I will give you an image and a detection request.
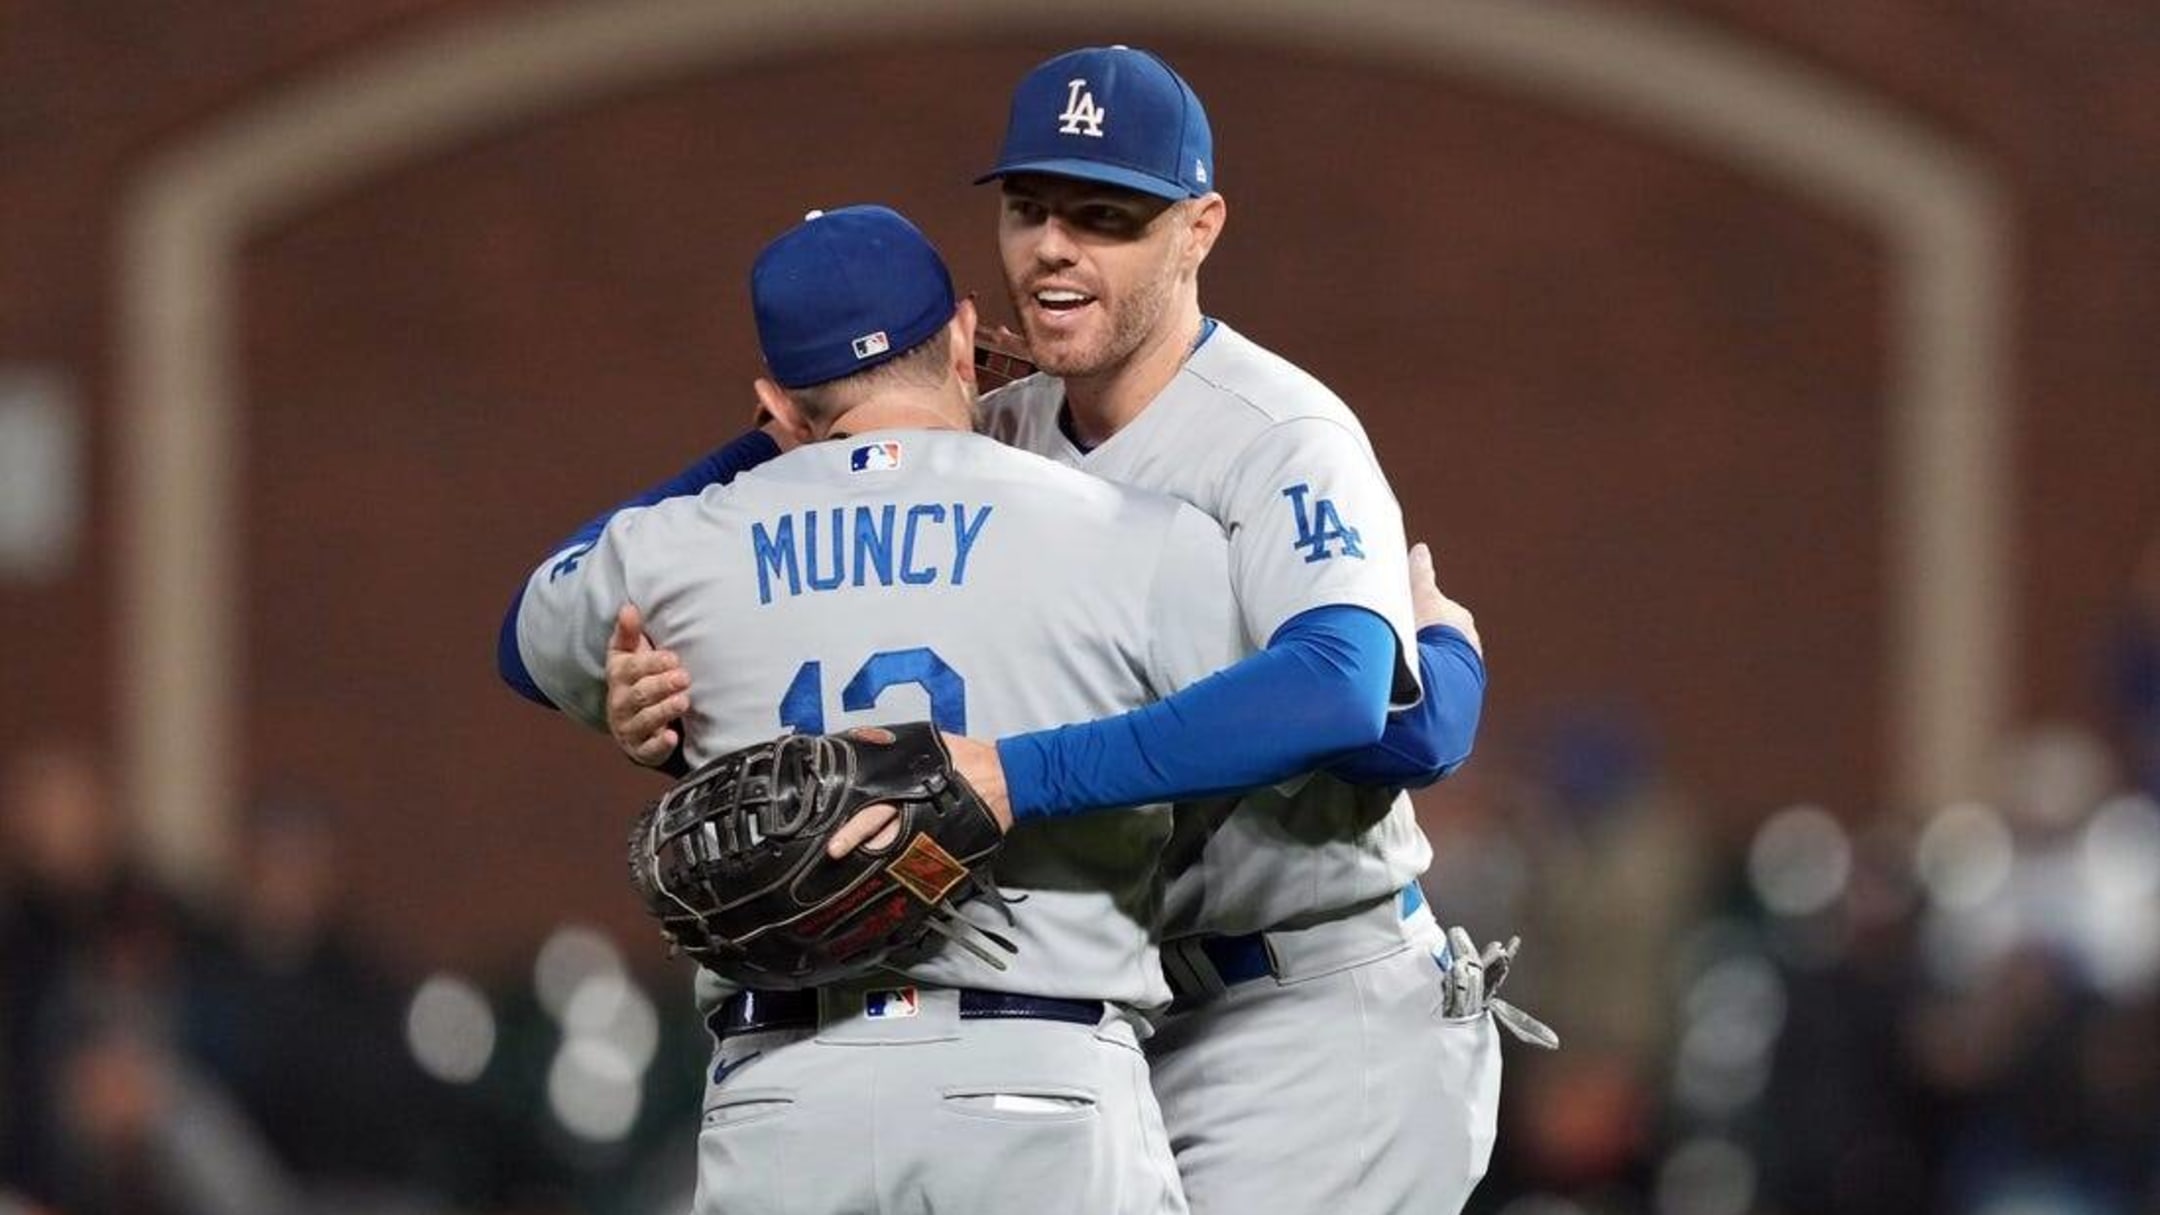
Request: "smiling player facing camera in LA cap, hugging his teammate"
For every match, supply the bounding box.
[591,48,1499,1215]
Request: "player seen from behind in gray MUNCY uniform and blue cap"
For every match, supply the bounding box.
[505,208,1442,1213]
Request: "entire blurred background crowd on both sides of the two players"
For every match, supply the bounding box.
[0,547,2160,1215]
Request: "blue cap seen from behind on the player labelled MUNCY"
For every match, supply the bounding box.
[750,205,957,389]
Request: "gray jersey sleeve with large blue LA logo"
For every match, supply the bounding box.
[1223,417,1419,707]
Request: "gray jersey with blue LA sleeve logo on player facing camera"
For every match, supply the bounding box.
[981,324,1432,938]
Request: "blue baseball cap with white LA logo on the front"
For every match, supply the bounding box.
[974,45,1214,201]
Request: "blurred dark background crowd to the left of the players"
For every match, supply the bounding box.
[0,744,702,1215]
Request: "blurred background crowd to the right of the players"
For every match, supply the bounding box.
[1428,709,2160,1215]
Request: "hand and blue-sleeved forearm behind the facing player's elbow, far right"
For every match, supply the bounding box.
[1328,545,1486,789]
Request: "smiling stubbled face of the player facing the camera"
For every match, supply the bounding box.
[998,173,1186,378]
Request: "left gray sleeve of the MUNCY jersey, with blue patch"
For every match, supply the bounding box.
[518,506,650,731]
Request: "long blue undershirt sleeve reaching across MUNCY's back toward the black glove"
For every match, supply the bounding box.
[998,605,1395,819]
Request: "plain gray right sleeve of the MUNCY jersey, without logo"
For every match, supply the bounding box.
[1147,504,1257,696]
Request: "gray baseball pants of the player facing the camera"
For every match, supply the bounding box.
[1147,902,1501,1215]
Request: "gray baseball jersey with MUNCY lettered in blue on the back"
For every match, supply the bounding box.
[518,430,1244,1007]
